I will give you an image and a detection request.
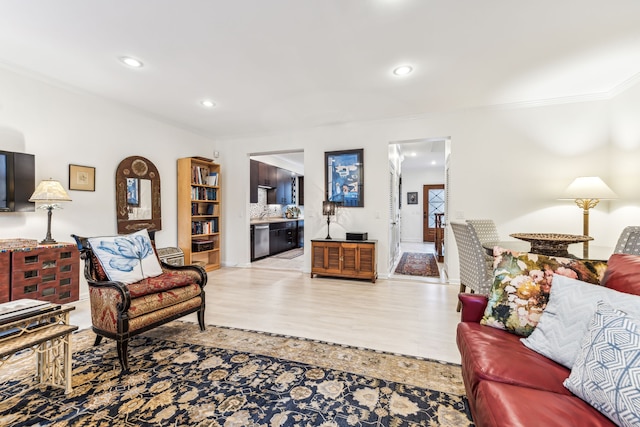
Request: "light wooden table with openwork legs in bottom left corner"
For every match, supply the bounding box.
[0,299,78,393]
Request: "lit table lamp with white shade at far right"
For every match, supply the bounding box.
[561,176,618,258]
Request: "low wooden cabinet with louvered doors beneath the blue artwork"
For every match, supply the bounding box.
[311,239,378,283]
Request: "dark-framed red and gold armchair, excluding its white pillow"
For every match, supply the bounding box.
[72,233,207,371]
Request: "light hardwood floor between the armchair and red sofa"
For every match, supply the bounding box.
[71,244,460,363]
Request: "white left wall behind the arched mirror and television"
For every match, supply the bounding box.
[0,69,215,295]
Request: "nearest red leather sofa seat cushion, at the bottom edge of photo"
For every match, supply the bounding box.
[472,381,614,427]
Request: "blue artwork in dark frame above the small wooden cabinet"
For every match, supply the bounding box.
[324,148,364,208]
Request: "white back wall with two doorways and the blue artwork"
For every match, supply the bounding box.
[220,86,640,282]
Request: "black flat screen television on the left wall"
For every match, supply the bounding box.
[0,150,36,212]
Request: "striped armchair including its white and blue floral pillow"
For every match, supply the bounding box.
[72,230,207,371]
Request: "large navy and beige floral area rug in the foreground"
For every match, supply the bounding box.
[0,322,473,427]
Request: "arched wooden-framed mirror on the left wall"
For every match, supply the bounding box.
[116,156,162,234]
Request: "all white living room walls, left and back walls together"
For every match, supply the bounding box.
[0,64,640,288]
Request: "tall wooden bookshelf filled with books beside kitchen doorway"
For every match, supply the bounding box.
[178,157,222,271]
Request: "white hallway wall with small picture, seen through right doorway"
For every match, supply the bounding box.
[401,165,444,242]
